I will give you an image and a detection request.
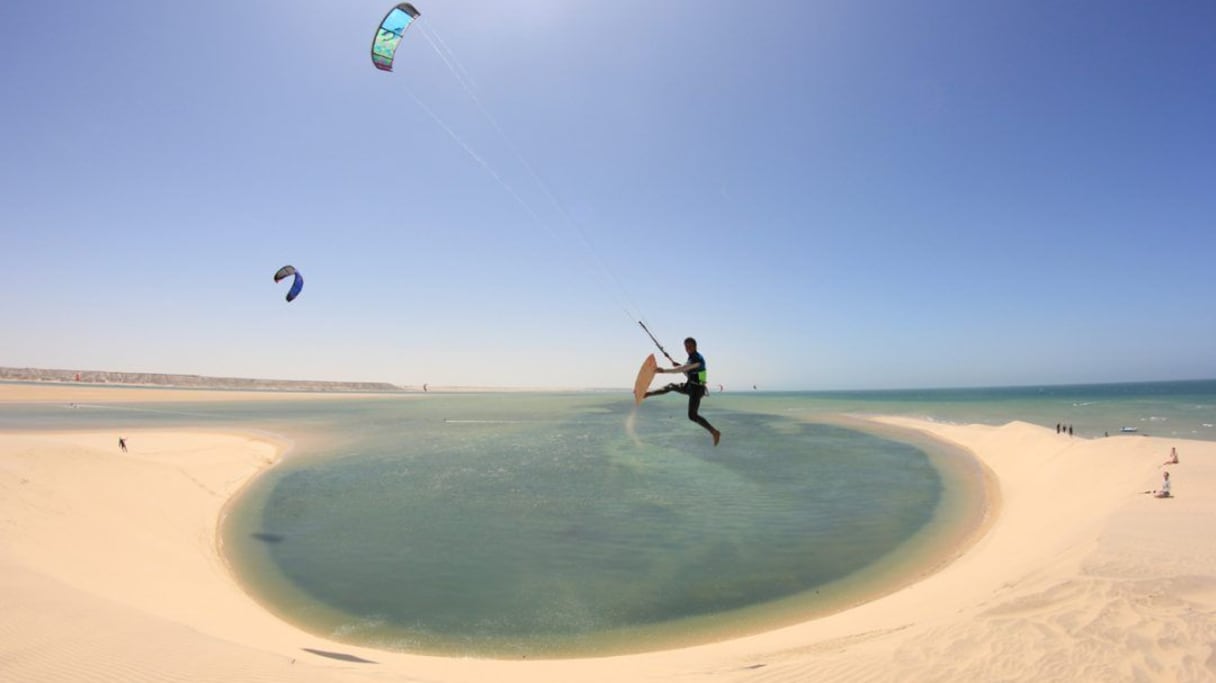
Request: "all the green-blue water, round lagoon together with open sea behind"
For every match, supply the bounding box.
[0,382,1216,657]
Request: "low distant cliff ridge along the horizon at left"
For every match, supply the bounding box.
[0,367,410,393]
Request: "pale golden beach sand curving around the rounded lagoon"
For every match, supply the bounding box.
[0,386,1216,683]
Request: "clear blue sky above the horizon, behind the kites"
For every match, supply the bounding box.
[0,0,1216,389]
